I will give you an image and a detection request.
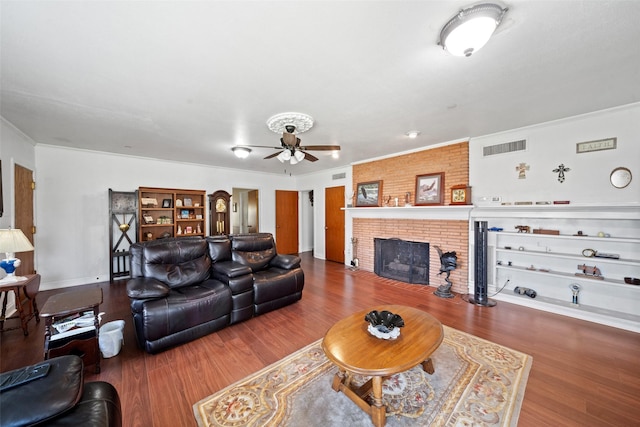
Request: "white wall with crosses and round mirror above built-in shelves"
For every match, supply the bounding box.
[469,103,640,205]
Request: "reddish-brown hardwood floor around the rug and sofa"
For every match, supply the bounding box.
[0,254,640,427]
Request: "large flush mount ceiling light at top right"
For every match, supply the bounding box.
[438,3,508,56]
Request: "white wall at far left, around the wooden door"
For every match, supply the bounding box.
[0,117,37,231]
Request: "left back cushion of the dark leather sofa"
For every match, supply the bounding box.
[142,239,211,289]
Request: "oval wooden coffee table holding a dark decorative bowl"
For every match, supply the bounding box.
[322,305,444,427]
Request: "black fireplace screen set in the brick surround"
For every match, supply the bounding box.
[373,238,429,285]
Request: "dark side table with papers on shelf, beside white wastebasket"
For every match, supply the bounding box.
[40,288,102,373]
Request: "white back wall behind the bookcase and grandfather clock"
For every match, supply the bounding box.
[35,145,296,289]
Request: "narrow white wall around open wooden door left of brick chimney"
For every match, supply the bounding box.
[297,166,352,260]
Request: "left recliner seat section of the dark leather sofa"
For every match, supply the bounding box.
[127,238,231,353]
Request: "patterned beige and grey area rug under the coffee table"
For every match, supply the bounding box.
[193,326,532,427]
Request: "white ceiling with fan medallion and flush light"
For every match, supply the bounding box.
[0,0,640,175]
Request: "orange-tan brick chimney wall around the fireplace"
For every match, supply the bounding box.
[353,142,469,294]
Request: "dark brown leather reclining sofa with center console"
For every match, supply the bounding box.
[127,233,304,353]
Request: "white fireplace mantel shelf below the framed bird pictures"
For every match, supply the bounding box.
[342,205,473,221]
